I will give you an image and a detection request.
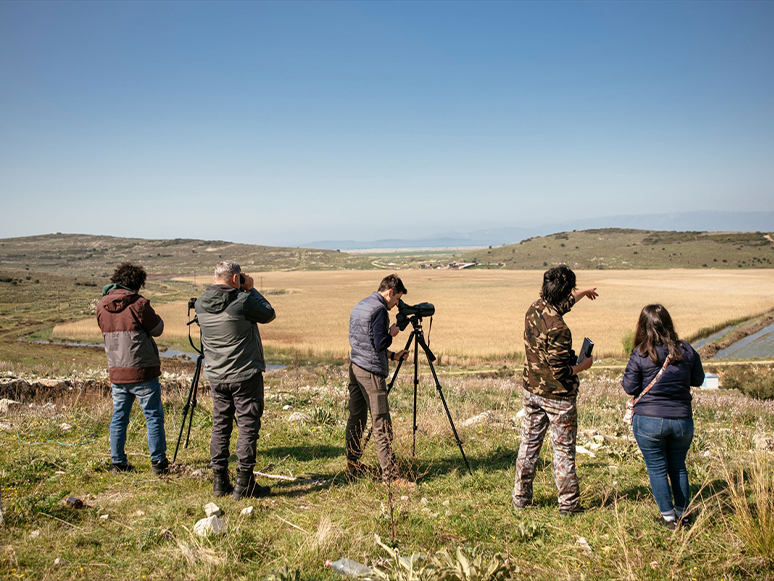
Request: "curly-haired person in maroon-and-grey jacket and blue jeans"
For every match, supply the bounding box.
[97,262,169,476]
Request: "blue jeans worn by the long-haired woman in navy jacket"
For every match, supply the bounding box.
[632,414,693,515]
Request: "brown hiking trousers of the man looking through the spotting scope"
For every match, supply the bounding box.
[346,363,398,481]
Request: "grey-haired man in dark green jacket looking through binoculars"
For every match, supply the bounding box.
[196,260,275,500]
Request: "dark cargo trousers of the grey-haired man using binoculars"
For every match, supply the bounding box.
[210,373,263,472]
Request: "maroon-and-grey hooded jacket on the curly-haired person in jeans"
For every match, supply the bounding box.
[97,288,164,384]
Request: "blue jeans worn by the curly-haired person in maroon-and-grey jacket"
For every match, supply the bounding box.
[110,377,167,464]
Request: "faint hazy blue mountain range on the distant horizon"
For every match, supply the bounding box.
[301,211,774,250]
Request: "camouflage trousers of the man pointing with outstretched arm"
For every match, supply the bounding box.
[513,390,580,510]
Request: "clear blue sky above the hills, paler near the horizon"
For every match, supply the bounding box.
[0,1,774,245]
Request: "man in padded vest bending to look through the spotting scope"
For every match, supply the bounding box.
[346,274,413,487]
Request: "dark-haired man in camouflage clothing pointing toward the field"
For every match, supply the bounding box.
[512,265,598,515]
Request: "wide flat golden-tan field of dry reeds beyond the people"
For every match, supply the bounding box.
[54,270,774,358]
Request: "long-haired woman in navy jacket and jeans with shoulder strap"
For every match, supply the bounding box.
[621,305,704,529]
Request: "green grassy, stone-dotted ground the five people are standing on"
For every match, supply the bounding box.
[0,365,774,580]
